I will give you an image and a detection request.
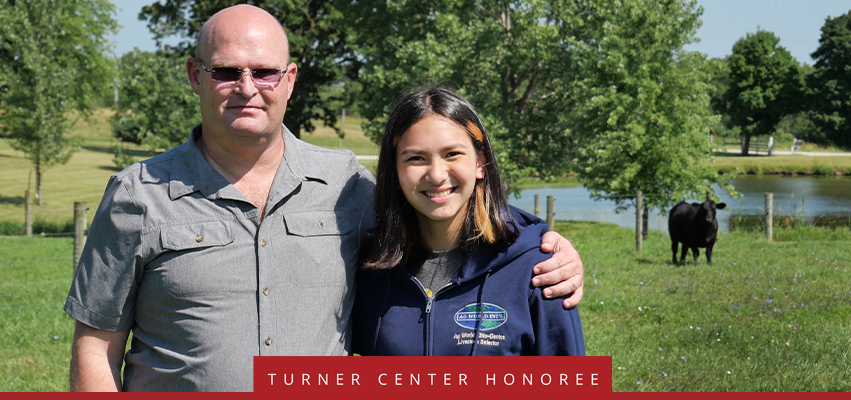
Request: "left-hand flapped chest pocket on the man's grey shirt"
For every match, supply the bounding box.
[153,221,248,297]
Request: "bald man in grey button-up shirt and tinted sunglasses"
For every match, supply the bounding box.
[65,5,582,391]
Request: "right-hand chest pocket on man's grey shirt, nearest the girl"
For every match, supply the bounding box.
[284,210,359,287]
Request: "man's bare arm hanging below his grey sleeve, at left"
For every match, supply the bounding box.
[70,321,130,392]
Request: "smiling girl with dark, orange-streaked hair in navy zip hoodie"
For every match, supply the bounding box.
[352,88,585,356]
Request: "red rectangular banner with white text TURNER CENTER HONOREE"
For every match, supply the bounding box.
[254,357,612,400]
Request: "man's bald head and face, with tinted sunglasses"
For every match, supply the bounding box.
[186,5,298,145]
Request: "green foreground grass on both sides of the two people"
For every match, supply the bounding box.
[0,222,851,392]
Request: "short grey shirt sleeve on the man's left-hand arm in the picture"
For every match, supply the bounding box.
[65,176,143,331]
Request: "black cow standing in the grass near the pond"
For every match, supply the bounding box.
[668,200,727,265]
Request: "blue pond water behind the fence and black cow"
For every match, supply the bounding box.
[509,175,851,232]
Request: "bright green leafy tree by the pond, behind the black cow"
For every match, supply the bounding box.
[559,0,735,210]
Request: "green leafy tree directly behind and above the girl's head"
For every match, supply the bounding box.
[350,0,581,184]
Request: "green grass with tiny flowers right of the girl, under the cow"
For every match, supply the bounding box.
[556,223,851,392]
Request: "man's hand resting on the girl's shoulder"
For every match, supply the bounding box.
[532,231,585,308]
